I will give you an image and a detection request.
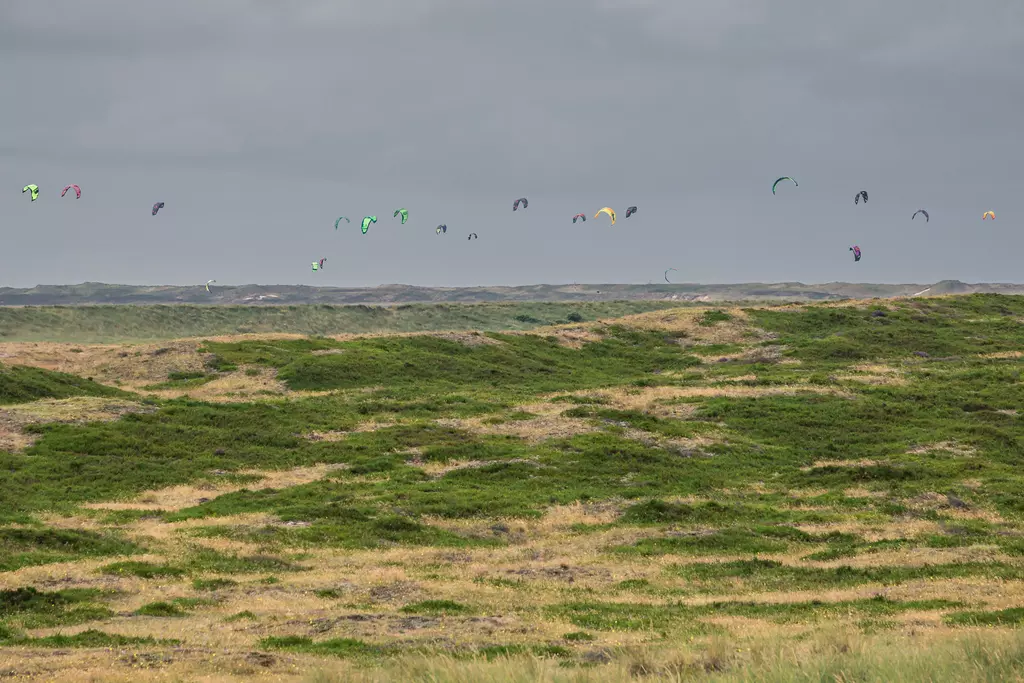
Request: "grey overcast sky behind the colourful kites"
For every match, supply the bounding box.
[0,0,1024,287]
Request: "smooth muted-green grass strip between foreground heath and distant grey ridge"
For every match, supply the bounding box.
[0,301,680,343]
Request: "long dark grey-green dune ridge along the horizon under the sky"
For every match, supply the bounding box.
[0,280,1024,306]
